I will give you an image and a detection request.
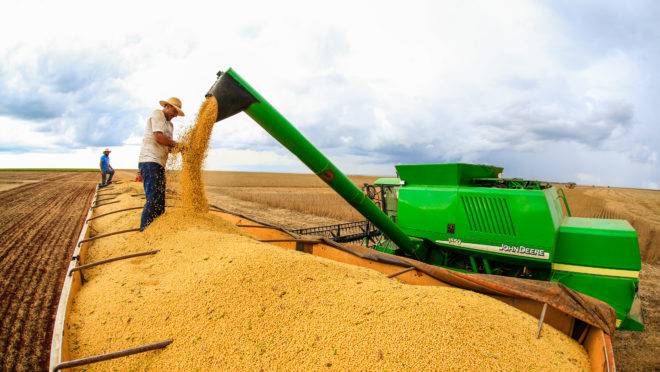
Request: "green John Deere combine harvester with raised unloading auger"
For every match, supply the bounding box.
[207,69,643,330]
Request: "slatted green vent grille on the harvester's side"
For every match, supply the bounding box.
[461,195,516,236]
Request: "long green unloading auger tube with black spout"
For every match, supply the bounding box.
[206,69,427,261]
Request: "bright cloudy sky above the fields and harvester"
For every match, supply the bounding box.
[0,0,660,188]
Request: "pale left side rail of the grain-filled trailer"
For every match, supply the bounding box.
[48,186,99,371]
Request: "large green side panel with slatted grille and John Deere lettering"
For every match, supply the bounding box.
[397,183,559,264]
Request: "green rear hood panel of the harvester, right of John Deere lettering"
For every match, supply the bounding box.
[555,217,641,270]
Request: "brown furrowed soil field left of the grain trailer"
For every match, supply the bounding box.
[0,172,98,371]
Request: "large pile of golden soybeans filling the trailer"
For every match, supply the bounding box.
[69,183,589,370]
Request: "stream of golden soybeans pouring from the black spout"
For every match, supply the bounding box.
[179,96,218,212]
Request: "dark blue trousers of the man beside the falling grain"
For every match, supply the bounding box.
[138,162,165,231]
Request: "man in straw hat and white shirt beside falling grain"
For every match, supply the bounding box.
[138,97,184,230]
